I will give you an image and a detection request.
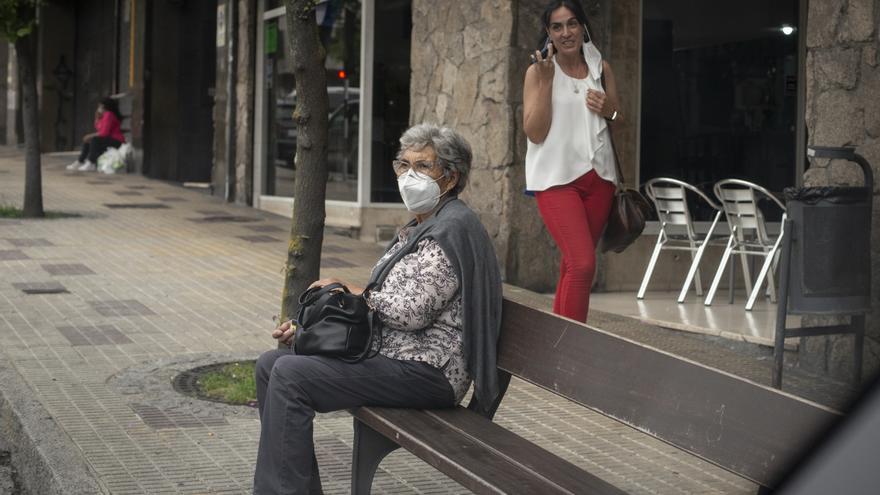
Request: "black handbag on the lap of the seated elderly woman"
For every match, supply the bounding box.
[293,283,382,363]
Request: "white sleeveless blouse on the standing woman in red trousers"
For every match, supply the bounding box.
[526,48,617,191]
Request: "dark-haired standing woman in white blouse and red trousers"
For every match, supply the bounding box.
[523,0,620,322]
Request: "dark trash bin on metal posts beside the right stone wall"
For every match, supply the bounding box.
[773,146,874,388]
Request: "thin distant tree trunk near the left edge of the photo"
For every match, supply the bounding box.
[15,34,45,218]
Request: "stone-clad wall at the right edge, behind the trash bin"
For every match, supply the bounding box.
[799,0,880,379]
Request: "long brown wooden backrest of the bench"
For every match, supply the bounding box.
[498,298,840,487]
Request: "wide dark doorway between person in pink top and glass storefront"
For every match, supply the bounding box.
[144,0,217,182]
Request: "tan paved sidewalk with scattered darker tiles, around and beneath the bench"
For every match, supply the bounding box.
[0,149,852,494]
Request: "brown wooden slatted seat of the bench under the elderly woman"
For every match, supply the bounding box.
[353,407,624,494]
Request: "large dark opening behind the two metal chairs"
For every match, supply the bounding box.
[640,0,802,211]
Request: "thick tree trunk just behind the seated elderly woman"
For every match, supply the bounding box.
[281,0,329,321]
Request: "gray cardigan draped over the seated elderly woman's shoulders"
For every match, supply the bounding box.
[370,197,502,415]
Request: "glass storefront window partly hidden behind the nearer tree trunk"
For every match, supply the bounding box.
[263,0,361,201]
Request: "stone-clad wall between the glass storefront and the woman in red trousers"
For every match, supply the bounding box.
[410,0,555,289]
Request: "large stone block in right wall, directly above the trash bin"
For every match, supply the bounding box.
[810,89,865,146]
